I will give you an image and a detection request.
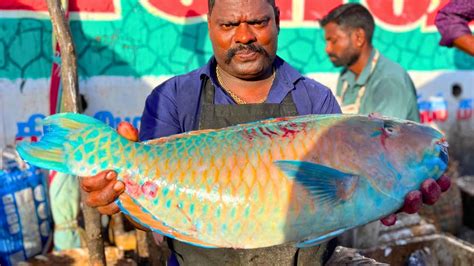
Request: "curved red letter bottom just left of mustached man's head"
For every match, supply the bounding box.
[145,0,207,18]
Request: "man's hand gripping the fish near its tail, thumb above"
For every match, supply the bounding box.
[80,122,138,215]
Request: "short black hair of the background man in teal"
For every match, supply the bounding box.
[319,3,375,44]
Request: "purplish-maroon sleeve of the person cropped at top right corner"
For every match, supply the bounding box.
[435,0,474,47]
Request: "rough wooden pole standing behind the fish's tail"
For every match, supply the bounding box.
[47,0,106,266]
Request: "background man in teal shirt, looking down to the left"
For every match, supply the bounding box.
[320,3,419,121]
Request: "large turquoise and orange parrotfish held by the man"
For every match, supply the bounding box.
[17,113,448,249]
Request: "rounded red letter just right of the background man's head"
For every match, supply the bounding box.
[365,0,431,26]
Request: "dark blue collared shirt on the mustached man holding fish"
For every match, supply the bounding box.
[140,57,341,141]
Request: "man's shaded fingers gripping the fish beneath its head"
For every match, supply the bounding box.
[380,175,451,226]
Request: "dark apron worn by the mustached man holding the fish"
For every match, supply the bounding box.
[170,78,326,266]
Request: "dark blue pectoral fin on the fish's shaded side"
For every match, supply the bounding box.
[274,160,359,205]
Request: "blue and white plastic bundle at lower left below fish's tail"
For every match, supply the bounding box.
[0,158,52,266]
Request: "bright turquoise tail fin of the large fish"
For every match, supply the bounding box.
[16,113,118,175]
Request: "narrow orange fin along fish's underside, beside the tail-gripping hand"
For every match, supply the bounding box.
[117,193,217,248]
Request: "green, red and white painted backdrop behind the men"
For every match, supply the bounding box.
[0,0,474,172]
